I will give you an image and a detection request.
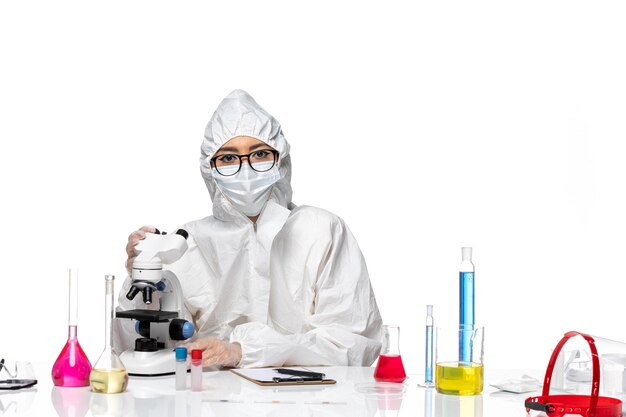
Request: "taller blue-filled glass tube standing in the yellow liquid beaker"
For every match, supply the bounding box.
[459,247,475,362]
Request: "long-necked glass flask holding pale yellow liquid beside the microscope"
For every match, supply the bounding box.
[89,275,128,394]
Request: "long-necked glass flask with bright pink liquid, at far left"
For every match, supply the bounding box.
[52,269,91,387]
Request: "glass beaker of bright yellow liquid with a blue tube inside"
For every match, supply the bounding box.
[435,326,484,395]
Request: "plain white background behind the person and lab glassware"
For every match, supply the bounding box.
[0,0,626,378]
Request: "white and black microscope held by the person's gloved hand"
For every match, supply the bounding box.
[116,229,194,376]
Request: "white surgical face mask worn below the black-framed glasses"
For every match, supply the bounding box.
[213,161,280,216]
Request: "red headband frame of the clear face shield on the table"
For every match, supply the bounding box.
[524,331,622,417]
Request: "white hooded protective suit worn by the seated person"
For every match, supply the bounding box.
[114,90,382,367]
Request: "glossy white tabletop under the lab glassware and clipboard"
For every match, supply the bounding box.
[0,364,541,417]
